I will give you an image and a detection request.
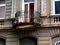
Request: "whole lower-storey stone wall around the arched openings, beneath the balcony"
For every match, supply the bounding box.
[0,27,60,45]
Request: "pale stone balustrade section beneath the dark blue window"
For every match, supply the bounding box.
[41,16,60,27]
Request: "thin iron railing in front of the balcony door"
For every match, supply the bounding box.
[14,12,40,23]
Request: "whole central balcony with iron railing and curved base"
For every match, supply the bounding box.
[13,13,40,30]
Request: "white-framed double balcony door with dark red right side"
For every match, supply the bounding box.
[24,2,34,22]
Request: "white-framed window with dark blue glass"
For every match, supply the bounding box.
[51,0,60,14]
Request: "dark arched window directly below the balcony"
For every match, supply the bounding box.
[20,37,37,45]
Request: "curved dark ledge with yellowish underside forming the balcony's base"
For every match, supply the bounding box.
[13,23,40,30]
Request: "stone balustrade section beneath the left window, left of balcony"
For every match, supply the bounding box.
[0,18,14,30]
